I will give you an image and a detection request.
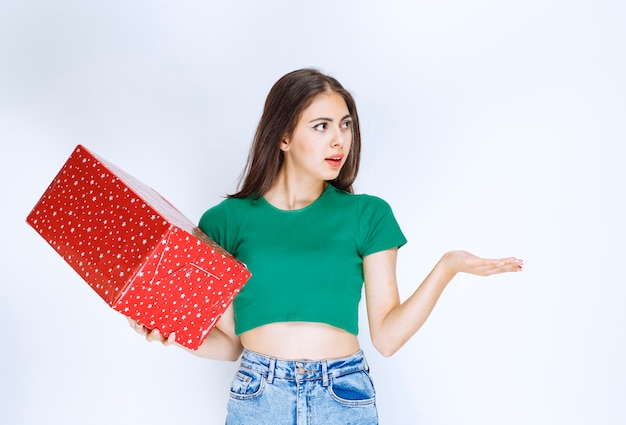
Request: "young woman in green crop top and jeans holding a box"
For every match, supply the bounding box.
[131,69,522,425]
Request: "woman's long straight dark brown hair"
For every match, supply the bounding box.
[228,68,361,198]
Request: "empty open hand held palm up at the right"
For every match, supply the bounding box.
[443,251,524,276]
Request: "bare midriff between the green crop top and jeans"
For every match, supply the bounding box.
[240,322,360,360]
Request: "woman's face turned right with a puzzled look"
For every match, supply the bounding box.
[280,92,352,181]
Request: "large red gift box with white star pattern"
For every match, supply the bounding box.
[26,145,250,350]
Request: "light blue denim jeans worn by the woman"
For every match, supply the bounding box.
[226,350,378,425]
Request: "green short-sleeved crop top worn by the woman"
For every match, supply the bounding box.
[199,185,406,335]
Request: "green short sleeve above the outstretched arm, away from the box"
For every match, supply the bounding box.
[359,195,407,257]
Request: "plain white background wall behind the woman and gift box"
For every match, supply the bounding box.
[0,0,626,425]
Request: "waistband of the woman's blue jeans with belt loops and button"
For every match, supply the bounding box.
[241,348,369,386]
